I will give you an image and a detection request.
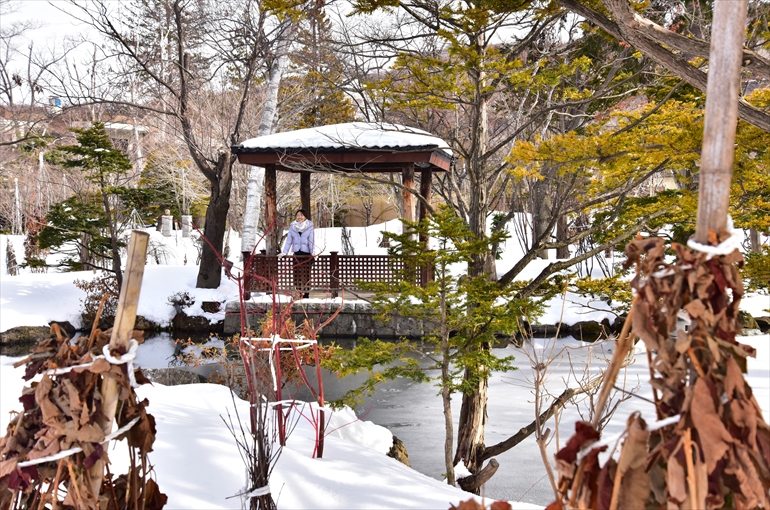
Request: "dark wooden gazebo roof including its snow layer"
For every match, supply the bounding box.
[232,122,452,172]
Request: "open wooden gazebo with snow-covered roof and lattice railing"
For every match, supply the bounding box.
[232,122,452,295]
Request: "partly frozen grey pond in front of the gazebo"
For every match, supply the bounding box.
[135,335,654,505]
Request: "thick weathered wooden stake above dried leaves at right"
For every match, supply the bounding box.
[695,0,747,244]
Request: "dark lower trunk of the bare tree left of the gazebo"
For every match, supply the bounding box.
[195,151,232,289]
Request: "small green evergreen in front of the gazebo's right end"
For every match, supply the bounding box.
[331,206,550,491]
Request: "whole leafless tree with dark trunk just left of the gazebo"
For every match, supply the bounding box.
[47,0,296,288]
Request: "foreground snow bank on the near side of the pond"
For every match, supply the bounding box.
[0,356,541,510]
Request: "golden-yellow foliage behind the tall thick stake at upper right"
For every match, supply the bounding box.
[508,90,770,241]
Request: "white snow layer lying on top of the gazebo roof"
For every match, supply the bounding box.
[233,122,452,158]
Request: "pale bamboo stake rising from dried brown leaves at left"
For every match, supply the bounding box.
[89,230,150,497]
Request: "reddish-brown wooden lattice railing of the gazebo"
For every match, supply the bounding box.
[244,251,433,297]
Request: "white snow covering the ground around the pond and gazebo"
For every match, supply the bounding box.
[0,221,770,509]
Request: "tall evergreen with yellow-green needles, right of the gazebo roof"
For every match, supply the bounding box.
[344,0,652,484]
